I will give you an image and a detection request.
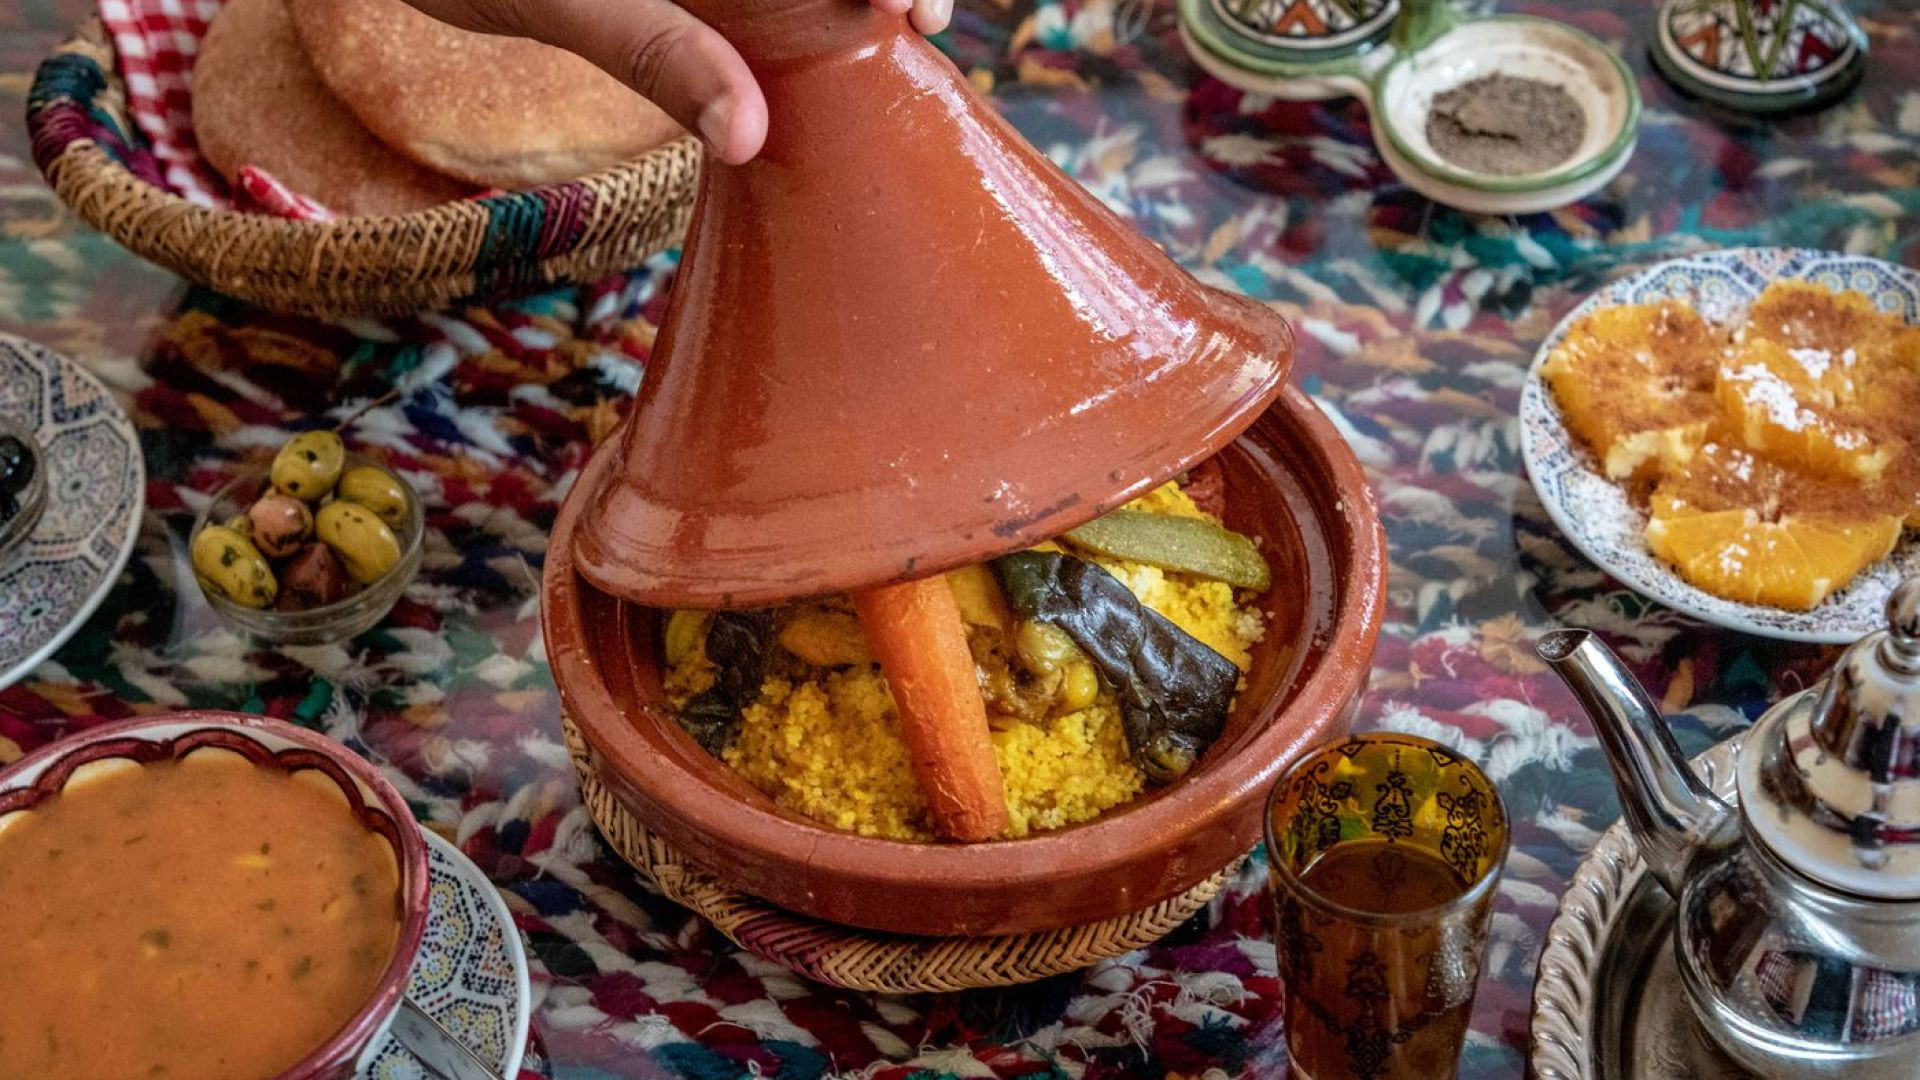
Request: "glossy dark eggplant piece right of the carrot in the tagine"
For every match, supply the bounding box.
[993,552,1240,784]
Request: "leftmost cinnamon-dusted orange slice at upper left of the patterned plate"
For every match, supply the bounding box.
[1540,302,1722,480]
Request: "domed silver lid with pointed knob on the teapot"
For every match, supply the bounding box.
[1741,577,1920,899]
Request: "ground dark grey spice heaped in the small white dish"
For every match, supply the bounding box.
[1427,75,1586,177]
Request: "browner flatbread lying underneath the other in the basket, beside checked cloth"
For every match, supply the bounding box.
[194,0,474,213]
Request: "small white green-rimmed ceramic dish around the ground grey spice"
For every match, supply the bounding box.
[1371,15,1640,213]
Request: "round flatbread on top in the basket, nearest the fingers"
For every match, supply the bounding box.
[292,0,680,188]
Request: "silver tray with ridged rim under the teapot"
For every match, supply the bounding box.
[1528,732,1751,1080]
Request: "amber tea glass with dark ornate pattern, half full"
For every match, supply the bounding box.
[1267,732,1507,1080]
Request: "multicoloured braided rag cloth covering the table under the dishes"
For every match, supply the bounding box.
[0,0,1920,1080]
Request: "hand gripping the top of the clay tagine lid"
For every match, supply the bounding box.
[407,0,954,165]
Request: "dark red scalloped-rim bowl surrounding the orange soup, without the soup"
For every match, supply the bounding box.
[0,713,428,1080]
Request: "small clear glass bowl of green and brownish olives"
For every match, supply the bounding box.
[190,430,426,646]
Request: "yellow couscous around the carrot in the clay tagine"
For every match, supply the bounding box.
[664,482,1263,840]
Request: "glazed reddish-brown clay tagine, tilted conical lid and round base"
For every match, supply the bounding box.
[541,0,1384,936]
